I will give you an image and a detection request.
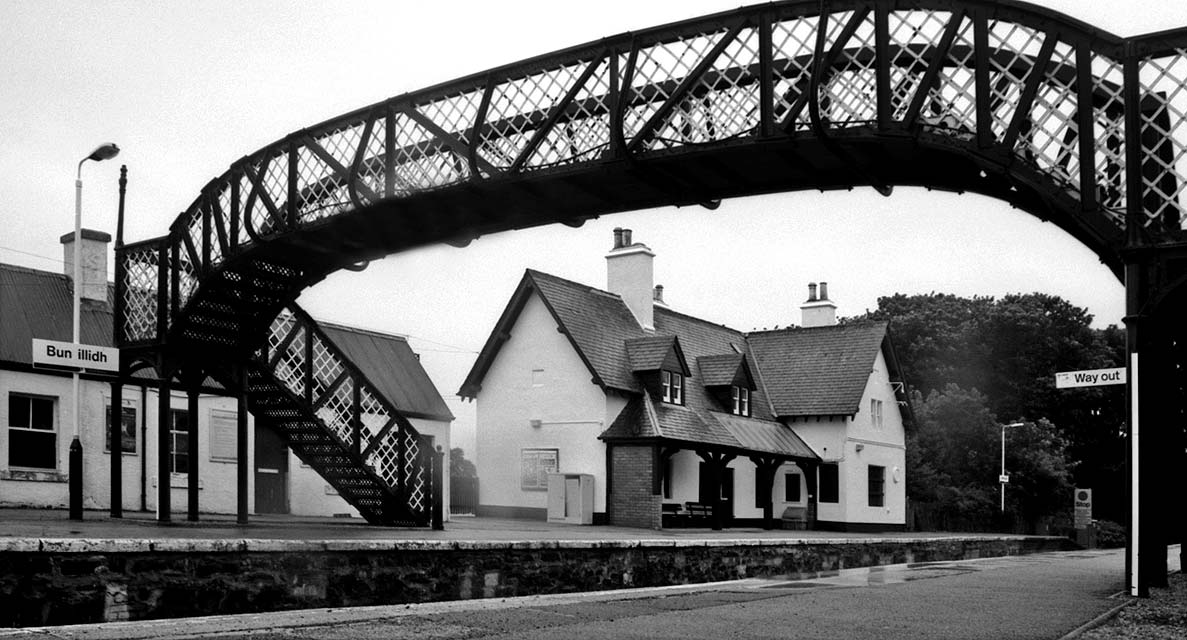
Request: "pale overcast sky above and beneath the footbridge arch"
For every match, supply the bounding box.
[0,0,1187,451]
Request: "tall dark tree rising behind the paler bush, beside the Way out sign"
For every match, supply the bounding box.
[865,293,1125,520]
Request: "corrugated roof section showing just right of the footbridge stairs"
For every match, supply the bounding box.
[318,322,453,422]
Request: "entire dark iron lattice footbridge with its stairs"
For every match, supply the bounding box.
[115,0,1187,596]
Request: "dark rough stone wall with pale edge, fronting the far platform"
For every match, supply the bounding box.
[0,537,1071,627]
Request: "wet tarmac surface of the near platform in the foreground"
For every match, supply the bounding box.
[0,547,1179,640]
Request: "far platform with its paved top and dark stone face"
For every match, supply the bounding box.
[0,509,1072,627]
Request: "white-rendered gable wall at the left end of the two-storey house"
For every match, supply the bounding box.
[476,293,623,512]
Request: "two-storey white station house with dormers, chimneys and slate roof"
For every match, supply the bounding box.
[458,229,910,531]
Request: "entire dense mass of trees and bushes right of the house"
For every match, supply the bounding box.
[861,293,1125,526]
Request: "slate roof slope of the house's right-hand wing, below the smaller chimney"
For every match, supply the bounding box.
[747,322,887,417]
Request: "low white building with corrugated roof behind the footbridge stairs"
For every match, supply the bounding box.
[0,229,453,518]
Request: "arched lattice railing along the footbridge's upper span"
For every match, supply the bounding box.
[121,0,1187,349]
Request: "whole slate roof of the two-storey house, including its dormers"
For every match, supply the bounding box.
[458,270,894,458]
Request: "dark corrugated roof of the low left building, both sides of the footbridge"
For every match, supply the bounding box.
[0,264,453,420]
